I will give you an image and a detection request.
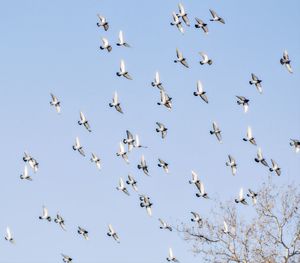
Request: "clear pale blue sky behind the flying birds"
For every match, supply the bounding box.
[0,0,300,263]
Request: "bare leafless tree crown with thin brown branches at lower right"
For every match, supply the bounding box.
[177,180,300,263]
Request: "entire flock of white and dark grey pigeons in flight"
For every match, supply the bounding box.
[5,3,300,263]
